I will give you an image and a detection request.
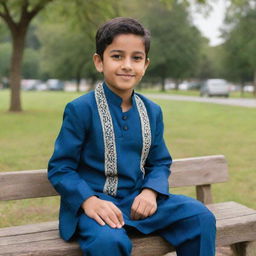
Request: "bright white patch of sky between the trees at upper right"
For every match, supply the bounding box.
[192,0,226,46]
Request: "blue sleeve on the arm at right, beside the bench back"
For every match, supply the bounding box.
[142,108,172,195]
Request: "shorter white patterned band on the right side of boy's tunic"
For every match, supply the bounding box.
[135,95,151,176]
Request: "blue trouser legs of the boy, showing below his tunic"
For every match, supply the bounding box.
[78,205,216,256]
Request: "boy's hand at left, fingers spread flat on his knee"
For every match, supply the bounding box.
[82,196,124,228]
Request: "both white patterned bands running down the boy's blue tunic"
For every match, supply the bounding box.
[95,84,151,196]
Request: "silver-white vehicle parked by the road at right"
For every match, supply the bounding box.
[200,79,229,97]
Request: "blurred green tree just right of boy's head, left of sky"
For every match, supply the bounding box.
[142,1,201,90]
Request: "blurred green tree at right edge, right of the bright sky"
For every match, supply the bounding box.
[224,1,256,96]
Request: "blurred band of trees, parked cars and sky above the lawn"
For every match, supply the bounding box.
[0,0,256,108]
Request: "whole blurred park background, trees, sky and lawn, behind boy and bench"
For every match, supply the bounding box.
[0,3,256,251]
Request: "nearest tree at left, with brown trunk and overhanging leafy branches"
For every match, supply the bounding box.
[0,0,120,111]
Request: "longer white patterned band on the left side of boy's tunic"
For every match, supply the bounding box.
[95,84,118,196]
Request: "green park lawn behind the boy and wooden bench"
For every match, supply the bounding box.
[0,91,256,227]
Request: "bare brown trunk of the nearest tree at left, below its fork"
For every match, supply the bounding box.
[9,31,26,111]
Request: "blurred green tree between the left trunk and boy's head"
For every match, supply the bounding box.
[37,0,119,91]
